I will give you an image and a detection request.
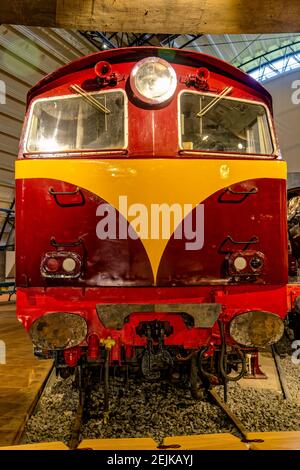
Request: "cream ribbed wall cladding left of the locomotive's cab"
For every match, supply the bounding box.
[0,25,96,211]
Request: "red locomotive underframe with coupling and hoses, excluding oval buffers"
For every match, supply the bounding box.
[17,284,300,386]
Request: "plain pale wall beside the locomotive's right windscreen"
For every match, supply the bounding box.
[263,70,300,186]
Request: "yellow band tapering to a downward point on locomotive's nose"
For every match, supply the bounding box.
[16,158,287,279]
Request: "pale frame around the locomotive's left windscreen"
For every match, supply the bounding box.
[23,88,128,158]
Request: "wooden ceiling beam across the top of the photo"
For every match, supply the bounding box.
[0,0,300,34]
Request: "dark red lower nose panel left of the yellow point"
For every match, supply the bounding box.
[16,179,153,287]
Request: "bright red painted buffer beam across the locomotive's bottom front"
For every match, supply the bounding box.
[17,285,287,349]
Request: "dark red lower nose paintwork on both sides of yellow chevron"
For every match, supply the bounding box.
[16,179,287,287]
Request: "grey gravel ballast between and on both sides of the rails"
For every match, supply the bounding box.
[23,336,300,443]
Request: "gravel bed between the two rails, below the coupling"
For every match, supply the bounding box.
[82,380,233,442]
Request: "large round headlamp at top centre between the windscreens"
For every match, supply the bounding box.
[130,57,177,104]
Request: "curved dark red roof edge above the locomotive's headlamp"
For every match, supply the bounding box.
[27,46,272,108]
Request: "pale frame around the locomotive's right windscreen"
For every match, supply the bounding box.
[177,89,279,160]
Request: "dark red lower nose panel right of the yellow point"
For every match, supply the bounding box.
[157,179,288,286]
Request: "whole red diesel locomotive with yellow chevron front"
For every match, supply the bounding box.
[16,47,296,395]
